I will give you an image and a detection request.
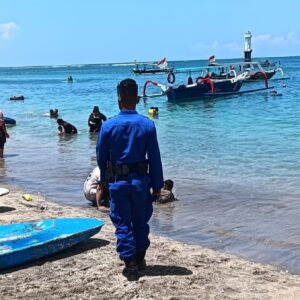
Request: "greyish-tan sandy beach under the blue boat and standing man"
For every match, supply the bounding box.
[0,186,300,299]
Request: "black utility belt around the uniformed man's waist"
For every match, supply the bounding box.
[112,162,148,180]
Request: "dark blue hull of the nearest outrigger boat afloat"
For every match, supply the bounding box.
[166,80,242,101]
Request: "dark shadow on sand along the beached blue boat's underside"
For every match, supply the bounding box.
[0,238,110,274]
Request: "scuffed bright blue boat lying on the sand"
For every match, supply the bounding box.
[0,218,104,269]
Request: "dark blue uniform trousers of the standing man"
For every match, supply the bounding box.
[109,181,153,260]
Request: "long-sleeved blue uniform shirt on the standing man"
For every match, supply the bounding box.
[96,110,163,190]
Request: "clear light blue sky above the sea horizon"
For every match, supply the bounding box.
[0,0,300,66]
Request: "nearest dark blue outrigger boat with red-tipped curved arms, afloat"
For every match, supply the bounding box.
[143,65,274,102]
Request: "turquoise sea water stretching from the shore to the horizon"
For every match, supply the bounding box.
[0,57,300,274]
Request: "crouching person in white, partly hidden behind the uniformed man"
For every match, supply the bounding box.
[83,167,109,212]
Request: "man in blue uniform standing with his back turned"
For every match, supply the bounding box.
[96,79,163,275]
